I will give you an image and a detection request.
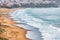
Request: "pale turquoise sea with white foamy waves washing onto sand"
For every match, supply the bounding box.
[10,8,60,40]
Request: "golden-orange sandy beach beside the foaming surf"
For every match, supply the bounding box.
[0,8,29,40]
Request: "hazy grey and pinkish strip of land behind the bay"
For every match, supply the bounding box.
[0,0,58,8]
